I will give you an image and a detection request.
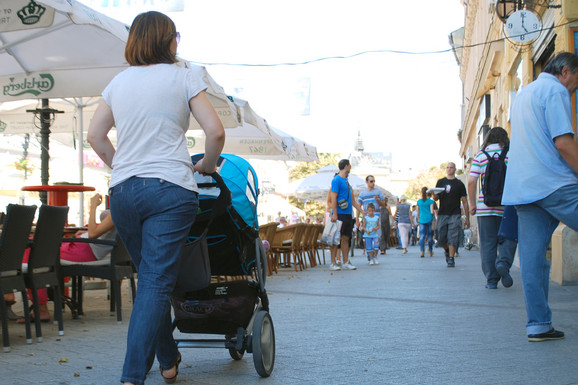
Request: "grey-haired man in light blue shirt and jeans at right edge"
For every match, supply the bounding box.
[502,52,578,342]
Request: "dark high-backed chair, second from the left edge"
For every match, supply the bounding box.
[24,205,68,342]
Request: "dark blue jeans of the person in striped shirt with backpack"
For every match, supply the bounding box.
[478,215,517,284]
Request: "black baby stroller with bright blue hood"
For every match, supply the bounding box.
[171,154,275,377]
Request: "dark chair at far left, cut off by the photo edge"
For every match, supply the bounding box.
[0,204,36,352]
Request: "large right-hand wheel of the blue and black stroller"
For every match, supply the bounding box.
[251,310,275,377]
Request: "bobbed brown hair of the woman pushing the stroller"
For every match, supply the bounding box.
[124,11,177,66]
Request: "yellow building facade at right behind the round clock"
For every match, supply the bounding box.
[450,0,578,283]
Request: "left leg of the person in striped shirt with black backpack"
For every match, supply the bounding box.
[477,215,502,287]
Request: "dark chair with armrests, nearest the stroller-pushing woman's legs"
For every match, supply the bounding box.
[60,236,136,323]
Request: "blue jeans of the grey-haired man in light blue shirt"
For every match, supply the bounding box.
[516,184,578,334]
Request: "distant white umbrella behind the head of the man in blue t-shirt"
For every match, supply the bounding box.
[286,164,392,203]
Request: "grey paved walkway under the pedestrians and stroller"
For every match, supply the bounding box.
[0,246,578,385]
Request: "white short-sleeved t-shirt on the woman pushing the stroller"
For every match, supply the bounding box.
[102,64,207,191]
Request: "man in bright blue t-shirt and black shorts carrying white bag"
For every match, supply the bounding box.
[329,159,362,270]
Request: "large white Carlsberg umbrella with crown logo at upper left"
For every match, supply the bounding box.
[0,0,240,220]
